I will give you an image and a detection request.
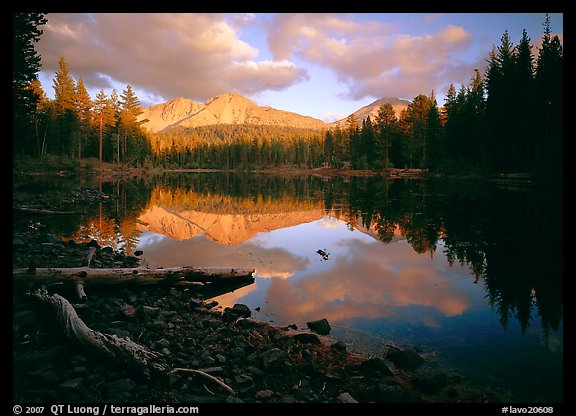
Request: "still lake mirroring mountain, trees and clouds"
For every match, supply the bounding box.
[13,172,563,403]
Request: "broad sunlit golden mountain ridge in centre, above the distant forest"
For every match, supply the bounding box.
[138,94,328,133]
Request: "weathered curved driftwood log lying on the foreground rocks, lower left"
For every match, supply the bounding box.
[31,289,235,395]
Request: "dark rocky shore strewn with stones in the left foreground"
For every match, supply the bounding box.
[12,230,512,403]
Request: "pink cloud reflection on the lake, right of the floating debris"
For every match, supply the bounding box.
[266,239,471,325]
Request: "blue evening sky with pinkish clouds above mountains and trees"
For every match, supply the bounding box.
[36,12,563,122]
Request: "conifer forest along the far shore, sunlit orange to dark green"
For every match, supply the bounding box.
[13,13,563,176]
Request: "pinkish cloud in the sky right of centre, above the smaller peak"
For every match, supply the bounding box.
[267,14,472,100]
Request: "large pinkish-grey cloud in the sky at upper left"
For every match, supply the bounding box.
[37,13,307,101]
